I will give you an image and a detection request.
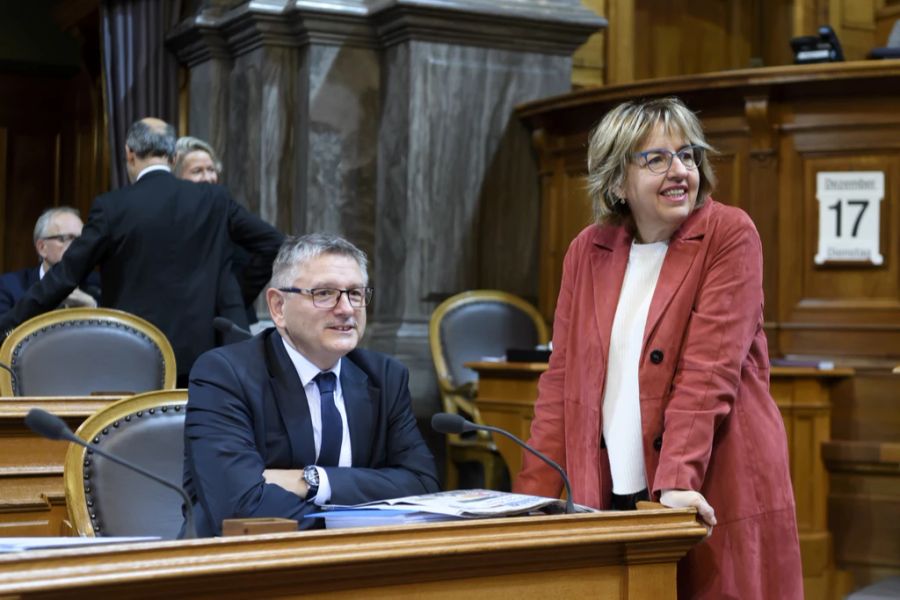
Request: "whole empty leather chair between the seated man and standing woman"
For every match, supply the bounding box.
[429,290,548,489]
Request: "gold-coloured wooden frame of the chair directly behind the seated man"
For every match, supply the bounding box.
[63,389,188,537]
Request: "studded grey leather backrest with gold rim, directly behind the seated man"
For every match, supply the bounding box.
[63,389,187,539]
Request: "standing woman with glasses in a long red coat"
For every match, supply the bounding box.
[516,98,803,600]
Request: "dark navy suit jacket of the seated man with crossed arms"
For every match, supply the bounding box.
[184,329,439,537]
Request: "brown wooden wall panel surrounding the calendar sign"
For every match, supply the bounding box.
[779,97,900,357]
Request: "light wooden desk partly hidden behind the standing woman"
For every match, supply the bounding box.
[466,362,854,598]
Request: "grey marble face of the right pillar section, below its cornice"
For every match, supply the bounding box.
[372,41,571,409]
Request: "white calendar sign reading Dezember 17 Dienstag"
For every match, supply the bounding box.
[813,171,884,265]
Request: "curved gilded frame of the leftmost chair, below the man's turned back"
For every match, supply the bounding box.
[0,308,176,396]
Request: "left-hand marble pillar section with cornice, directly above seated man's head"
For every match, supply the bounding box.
[169,0,380,253]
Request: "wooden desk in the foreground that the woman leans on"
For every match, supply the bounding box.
[0,509,706,600]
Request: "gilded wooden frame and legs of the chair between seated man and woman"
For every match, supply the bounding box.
[428,290,549,489]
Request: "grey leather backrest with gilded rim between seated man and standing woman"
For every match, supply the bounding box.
[429,290,548,392]
